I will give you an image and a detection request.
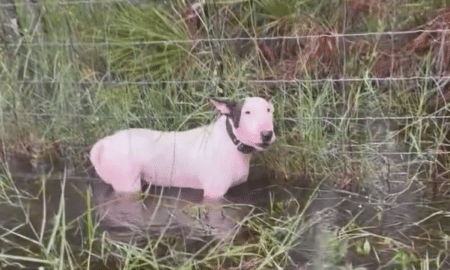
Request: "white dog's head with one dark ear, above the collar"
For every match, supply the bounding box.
[211,97,275,151]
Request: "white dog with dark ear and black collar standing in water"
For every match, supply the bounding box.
[90,97,275,199]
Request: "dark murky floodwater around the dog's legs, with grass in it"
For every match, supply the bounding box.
[0,144,450,269]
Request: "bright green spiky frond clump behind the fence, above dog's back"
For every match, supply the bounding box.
[106,4,196,80]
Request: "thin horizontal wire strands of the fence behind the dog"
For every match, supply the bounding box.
[0,0,450,158]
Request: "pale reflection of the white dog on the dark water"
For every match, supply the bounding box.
[91,180,250,240]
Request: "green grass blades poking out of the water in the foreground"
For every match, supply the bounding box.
[0,169,448,269]
